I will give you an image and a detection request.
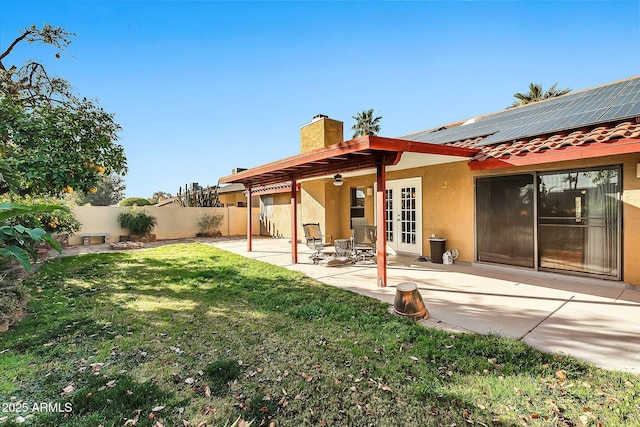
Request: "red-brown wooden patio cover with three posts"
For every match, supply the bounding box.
[220,136,480,286]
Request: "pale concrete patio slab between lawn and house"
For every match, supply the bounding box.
[211,238,640,374]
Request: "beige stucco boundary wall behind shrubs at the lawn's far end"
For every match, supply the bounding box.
[69,206,251,245]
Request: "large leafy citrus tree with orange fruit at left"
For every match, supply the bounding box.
[0,25,127,199]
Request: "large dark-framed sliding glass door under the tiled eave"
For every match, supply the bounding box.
[476,166,621,279]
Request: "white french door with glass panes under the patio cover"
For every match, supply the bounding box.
[385,177,422,254]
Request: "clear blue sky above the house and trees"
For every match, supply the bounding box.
[0,0,640,197]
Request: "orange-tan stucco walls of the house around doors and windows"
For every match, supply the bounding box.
[216,153,640,286]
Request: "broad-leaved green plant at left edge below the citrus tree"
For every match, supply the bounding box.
[0,203,67,271]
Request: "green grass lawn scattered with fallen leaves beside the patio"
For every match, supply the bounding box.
[0,244,640,427]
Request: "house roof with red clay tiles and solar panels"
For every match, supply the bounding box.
[401,76,640,161]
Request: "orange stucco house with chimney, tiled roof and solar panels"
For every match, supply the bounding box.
[221,77,640,285]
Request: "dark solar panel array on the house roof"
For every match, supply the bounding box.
[403,77,640,145]
